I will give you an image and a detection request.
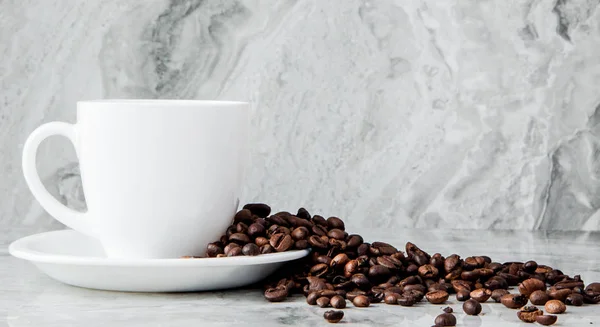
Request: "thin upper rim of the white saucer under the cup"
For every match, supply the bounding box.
[8,229,310,267]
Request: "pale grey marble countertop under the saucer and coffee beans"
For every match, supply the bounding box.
[0,230,600,327]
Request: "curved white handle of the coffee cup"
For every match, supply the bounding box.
[22,122,95,236]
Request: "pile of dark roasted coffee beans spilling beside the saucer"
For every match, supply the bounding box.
[199,203,600,326]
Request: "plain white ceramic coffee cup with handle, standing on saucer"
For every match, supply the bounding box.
[23,100,249,258]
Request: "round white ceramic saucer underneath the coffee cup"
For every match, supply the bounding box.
[9,230,310,292]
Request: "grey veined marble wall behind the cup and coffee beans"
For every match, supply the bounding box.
[0,0,600,238]
